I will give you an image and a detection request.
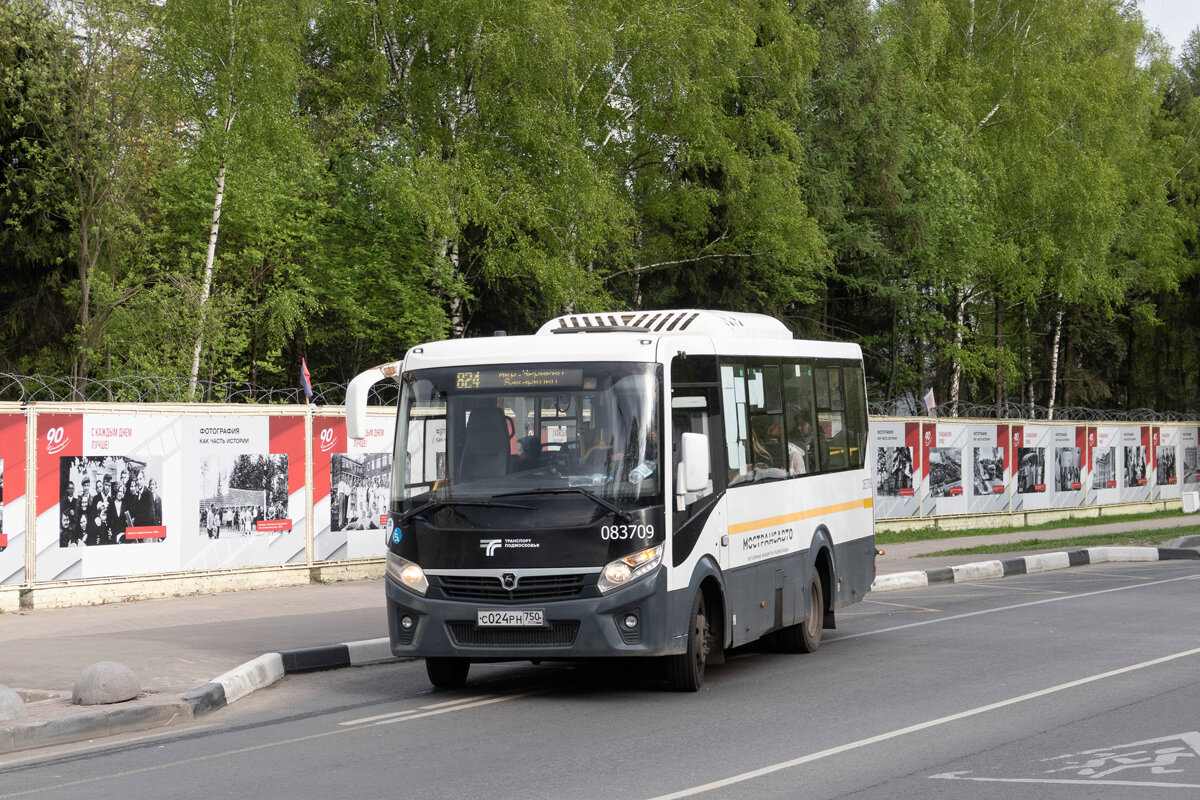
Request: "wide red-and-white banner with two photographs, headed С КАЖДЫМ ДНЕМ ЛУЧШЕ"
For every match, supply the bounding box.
[36,414,305,582]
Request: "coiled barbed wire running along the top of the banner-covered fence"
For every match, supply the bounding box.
[0,373,1200,422]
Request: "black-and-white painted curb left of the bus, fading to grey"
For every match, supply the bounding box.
[0,638,398,756]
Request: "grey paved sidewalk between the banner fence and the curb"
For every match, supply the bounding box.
[0,516,1200,756]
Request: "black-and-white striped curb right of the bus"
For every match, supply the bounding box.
[871,547,1200,591]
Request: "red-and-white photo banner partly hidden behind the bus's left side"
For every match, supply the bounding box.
[312,415,396,561]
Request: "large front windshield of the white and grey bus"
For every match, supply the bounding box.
[392,362,662,512]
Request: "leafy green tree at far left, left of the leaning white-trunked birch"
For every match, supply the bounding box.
[4,0,155,392]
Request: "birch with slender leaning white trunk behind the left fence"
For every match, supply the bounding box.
[155,0,319,393]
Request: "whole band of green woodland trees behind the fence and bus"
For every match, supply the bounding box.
[0,0,1200,410]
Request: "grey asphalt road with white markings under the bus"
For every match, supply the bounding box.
[0,561,1200,800]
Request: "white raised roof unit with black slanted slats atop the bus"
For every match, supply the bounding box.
[538,309,792,339]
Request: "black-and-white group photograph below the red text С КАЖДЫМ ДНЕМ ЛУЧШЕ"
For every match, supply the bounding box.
[59,456,164,547]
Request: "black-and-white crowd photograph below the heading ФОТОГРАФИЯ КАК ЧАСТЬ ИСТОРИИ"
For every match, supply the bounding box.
[197,453,290,539]
